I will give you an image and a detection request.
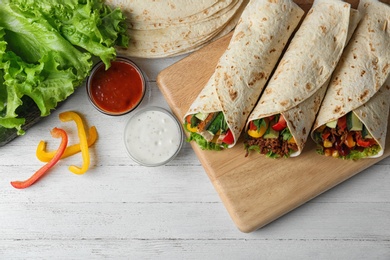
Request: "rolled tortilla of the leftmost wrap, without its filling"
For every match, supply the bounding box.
[183,0,304,147]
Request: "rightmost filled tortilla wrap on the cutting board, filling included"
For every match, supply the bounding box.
[311,0,390,159]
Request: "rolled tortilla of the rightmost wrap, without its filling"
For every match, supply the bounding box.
[312,0,390,157]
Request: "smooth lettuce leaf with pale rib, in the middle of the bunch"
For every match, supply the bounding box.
[0,1,92,79]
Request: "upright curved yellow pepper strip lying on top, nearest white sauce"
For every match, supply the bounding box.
[59,111,90,174]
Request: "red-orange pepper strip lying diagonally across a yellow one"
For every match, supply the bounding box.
[11,128,68,189]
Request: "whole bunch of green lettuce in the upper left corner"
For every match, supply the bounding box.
[0,0,128,134]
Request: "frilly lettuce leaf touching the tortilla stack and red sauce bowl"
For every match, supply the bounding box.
[9,0,128,68]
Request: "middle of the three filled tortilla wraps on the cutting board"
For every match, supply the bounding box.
[245,0,360,157]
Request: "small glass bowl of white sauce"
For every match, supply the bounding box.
[124,106,184,166]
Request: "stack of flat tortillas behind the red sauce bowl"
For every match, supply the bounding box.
[106,0,249,58]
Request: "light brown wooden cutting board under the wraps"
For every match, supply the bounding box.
[157,1,390,232]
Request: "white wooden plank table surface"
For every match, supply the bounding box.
[0,57,390,259]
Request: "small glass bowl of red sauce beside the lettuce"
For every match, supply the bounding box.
[86,57,146,116]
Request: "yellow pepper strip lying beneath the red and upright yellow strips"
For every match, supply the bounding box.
[36,126,98,162]
